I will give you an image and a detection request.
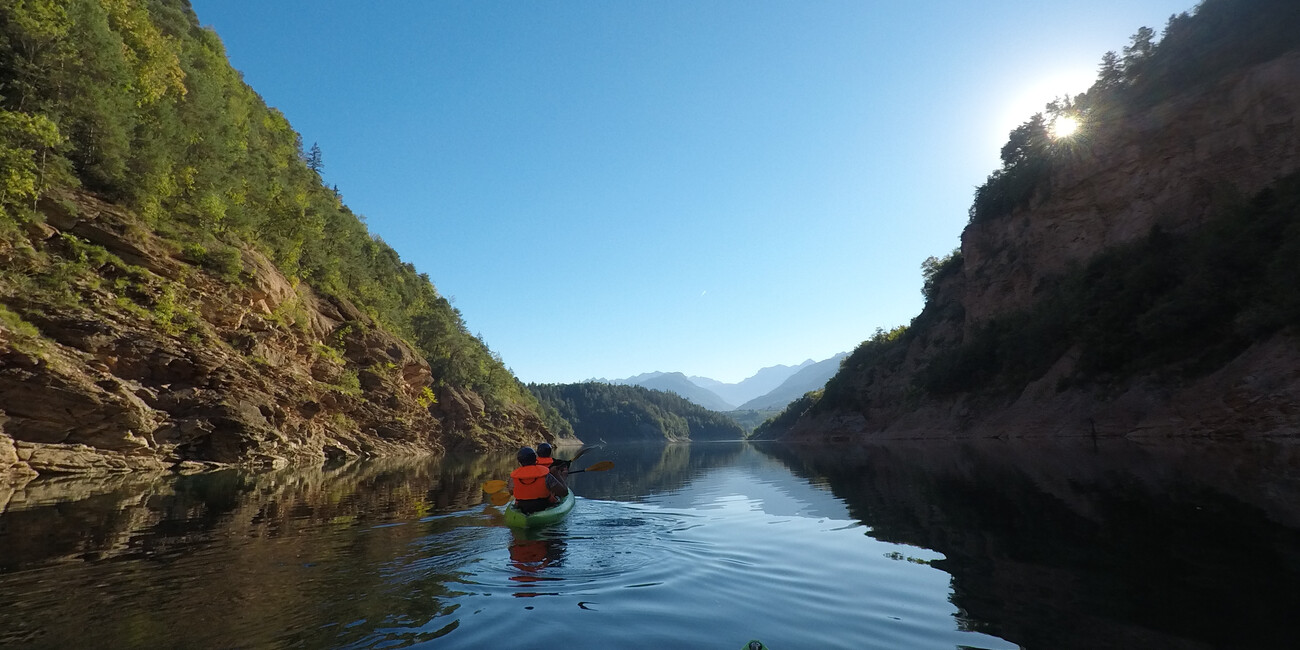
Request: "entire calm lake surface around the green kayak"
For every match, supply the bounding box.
[0,441,1300,650]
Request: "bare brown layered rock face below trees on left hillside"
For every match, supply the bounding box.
[0,194,551,476]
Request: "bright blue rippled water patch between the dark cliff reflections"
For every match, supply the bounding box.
[410,493,1014,649]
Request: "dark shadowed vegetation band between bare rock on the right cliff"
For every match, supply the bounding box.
[919,174,1300,394]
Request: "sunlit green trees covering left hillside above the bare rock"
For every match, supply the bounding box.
[0,0,537,431]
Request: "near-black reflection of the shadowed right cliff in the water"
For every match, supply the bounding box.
[762,441,1300,649]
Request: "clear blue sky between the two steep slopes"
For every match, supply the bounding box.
[192,0,1193,382]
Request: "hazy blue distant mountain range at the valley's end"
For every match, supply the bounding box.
[593,352,848,411]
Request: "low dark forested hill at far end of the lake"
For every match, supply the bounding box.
[528,382,745,445]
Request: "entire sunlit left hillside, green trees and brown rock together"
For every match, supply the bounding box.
[0,0,553,478]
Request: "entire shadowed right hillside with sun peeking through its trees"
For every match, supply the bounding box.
[762,0,1300,438]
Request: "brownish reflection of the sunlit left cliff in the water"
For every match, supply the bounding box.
[0,455,512,647]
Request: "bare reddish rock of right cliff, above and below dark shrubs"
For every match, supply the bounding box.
[770,52,1300,439]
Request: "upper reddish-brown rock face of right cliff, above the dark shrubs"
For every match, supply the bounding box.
[959,52,1300,325]
